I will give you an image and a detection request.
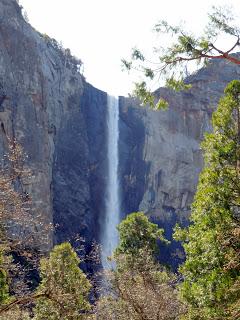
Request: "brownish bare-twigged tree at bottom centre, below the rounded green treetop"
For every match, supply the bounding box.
[96,249,184,320]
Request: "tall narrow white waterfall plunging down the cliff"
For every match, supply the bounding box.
[101,96,120,269]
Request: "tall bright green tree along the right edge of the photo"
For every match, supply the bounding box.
[176,80,240,320]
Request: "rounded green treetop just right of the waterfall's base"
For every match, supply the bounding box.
[115,212,167,257]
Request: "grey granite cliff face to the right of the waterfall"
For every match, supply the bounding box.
[120,61,240,265]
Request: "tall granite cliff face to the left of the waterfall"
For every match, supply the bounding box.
[0,0,107,250]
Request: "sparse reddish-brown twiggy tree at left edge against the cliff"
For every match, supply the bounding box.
[0,137,52,254]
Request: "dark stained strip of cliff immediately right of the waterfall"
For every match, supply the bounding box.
[119,97,149,217]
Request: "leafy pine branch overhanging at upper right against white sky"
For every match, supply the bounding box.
[122,7,240,109]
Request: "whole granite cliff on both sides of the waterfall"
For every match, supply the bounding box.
[0,0,240,265]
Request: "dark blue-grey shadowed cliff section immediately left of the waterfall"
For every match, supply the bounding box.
[53,84,107,248]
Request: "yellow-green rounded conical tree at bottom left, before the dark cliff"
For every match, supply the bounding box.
[34,243,91,320]
